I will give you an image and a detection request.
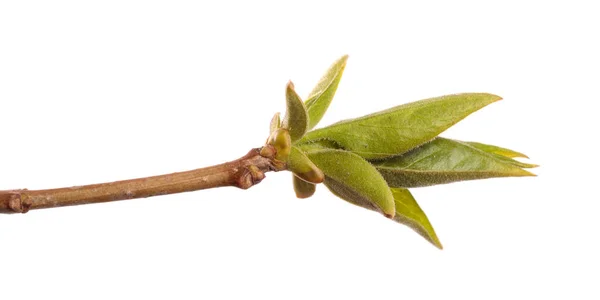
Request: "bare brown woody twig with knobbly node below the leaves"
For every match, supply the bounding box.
[0,146,283,213]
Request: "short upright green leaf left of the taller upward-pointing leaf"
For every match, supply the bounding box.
[281,81,308,142]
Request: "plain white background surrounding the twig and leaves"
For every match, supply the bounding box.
[0,1,600,299]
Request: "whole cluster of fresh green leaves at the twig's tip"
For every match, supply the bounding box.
[267,56,536,249]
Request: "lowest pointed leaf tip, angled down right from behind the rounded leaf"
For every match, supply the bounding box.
[391,188,443,249]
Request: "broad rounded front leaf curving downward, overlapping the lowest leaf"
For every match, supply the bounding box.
[307,149,395,218]
